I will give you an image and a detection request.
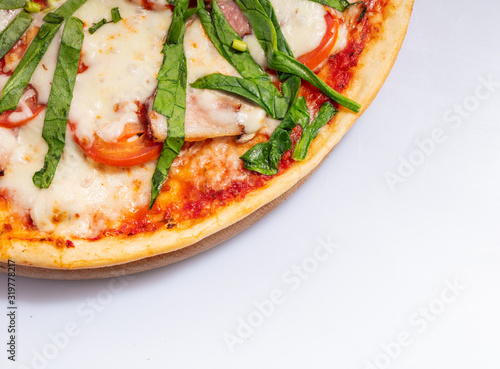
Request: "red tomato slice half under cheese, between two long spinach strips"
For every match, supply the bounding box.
[69,122,163,167]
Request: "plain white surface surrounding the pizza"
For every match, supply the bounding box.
[0,0,500,369]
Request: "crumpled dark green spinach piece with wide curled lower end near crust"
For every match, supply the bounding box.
[240,96,309,176]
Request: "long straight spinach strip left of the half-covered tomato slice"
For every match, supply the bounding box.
[33,17,83,188]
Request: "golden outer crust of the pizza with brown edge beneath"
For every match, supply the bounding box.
[0,0,413,279]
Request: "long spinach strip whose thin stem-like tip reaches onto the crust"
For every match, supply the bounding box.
[236,0,361,112]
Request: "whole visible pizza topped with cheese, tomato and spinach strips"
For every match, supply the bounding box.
[0,0,412,278]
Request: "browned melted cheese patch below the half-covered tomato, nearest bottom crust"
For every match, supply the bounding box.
[0,112,155,237]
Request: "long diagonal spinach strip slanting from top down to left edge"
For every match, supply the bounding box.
[0,0,86,114]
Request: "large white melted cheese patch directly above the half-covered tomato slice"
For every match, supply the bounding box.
[69,0,172,142]
